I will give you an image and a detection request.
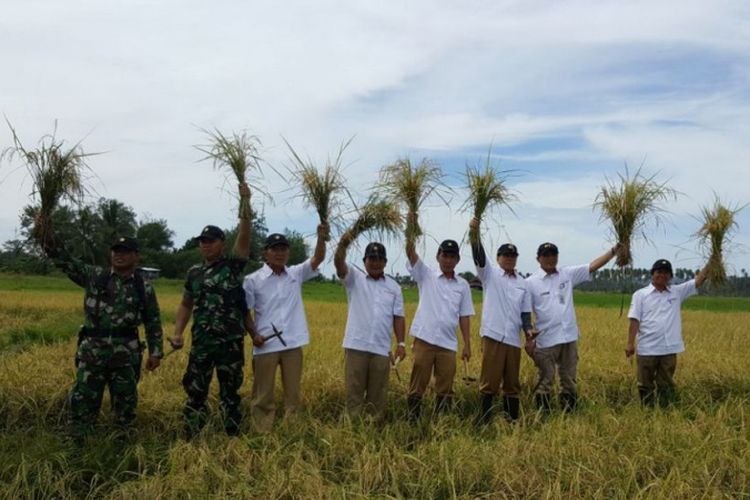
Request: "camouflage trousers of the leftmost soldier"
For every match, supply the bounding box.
[69,338,143,435]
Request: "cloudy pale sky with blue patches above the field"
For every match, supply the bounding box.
[0,0,750,274]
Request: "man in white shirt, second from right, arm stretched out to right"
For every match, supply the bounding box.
[526,243,619,412]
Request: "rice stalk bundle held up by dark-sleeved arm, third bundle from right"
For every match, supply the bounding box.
[462,150,517,234]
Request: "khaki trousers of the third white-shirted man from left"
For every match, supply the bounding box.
[409,339,456,396]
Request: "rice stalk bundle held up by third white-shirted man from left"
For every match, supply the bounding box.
[378,158,447,239]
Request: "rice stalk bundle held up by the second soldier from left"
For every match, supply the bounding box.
[195,129,261,219]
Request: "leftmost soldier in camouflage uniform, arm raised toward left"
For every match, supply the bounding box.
[43,231,163,438]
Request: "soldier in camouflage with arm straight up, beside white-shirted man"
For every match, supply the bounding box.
[172,184,250,437]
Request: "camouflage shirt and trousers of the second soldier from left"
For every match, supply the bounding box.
[182,257,247,434]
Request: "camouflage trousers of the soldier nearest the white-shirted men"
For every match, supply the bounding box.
[182,338,245,434]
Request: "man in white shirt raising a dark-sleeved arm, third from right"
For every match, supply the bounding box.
[469,219,533,425]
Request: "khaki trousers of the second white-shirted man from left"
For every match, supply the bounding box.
[344,349,391,419]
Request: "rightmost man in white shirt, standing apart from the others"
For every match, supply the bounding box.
[625,259,706,406]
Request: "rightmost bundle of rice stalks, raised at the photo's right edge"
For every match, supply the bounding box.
[695,196,747,285]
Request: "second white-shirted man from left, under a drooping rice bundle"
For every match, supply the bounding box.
[333,236,406,420]
